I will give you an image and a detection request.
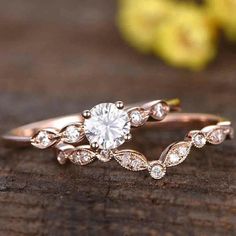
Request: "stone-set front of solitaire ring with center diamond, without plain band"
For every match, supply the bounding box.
[30,100,173,149]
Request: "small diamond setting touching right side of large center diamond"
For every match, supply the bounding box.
[128,107,149,127]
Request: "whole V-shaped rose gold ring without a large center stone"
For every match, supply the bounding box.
[57,113,234,179]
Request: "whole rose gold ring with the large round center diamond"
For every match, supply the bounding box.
[3,99,180,149]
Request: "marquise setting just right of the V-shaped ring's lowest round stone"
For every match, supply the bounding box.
[160,141,192,167]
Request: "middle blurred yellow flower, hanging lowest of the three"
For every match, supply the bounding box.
[154,4,216,70]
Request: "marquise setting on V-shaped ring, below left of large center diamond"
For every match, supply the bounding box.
[68,145,96,165]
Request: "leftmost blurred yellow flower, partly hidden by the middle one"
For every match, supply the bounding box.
[117,0,172,52]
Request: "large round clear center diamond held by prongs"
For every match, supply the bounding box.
[84,103,130,149]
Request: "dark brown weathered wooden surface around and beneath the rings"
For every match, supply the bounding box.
[0,0,236,236]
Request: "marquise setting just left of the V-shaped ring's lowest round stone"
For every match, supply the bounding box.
[114,150,148,171]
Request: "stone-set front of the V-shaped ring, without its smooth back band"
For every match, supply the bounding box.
[55,122,233,179]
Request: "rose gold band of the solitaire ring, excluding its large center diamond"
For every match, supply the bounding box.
[2,99,180,149]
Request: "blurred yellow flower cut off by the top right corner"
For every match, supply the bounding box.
[207,0,236,41]
